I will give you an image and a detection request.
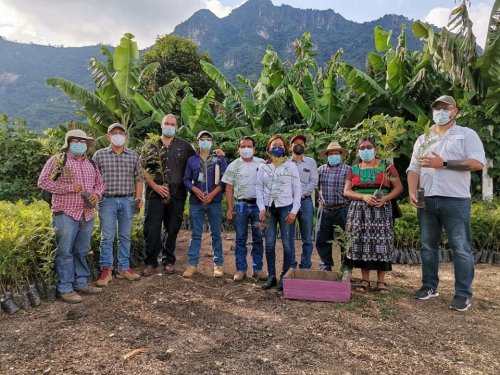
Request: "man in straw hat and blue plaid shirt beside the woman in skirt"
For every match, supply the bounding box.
[316,142,351,271]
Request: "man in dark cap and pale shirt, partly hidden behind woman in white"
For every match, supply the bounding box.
[289,134,318,269]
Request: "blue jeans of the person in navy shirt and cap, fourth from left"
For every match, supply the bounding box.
[188,202,224,267]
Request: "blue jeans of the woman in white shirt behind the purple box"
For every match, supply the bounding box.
[266,205,293,277]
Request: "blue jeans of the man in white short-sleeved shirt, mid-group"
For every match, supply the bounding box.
[235,202,264,272]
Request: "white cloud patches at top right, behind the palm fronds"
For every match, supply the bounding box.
[424,2,491,48]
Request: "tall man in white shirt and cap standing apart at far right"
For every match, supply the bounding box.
[407,95,486,311]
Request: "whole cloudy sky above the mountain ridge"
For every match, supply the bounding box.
[0,0,494,48]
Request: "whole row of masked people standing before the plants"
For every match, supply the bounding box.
[38,96,485,311]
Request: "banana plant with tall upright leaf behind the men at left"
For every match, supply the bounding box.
[47,33,186,145]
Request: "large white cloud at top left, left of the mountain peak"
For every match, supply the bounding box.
[0,0,209,48]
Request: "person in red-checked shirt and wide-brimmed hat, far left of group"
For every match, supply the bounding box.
[38,130,104,303]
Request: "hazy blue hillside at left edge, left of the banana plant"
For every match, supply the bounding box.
[0,38,100,130]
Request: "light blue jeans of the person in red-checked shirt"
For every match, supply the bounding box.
[52,213,94,293]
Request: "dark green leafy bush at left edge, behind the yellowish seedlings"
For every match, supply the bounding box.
[0,114,47,202]
